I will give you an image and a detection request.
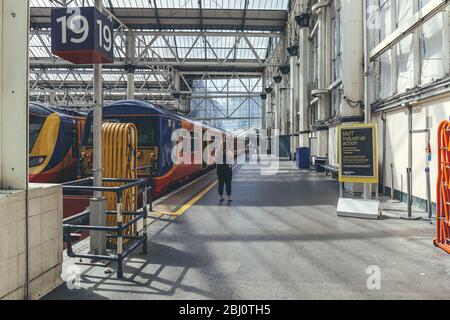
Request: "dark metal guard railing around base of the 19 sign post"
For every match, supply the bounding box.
[63,178,152,278]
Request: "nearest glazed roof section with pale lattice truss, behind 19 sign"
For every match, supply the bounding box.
[30,0,288,71]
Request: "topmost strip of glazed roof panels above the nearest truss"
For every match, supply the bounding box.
[31,0,288,31]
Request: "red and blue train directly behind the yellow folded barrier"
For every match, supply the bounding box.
[81,100,237,197]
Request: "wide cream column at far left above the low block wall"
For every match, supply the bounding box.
[0,0,29,190]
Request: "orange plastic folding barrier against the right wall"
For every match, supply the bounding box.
[434,121,450,254]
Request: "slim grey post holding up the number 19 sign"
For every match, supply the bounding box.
[90,0,106,255]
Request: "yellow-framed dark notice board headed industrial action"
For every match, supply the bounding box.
[338,124,378,184]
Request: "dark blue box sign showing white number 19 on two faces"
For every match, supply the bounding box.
[51,7,114,64]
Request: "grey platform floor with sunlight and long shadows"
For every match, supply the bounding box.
[46,162,450,300]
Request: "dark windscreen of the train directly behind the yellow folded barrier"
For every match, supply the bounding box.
[87,117,157,148]
